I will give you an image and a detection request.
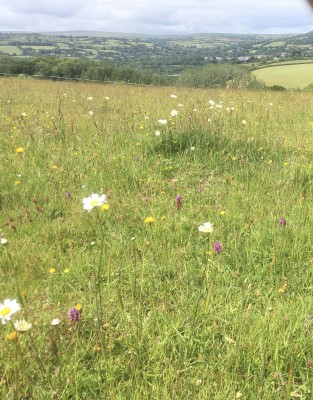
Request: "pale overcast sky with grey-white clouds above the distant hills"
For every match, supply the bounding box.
[0,0,313,34]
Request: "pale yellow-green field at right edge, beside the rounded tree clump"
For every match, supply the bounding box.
[254,63,313,89]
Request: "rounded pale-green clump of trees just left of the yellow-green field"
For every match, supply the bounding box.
[177,63,265,89]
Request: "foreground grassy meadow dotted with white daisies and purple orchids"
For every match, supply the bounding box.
[0,76,313,400]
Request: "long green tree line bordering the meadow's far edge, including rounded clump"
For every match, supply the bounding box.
[0,56,265,89]
